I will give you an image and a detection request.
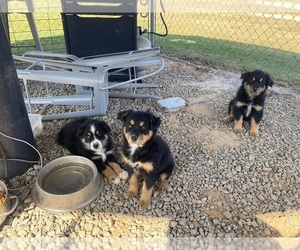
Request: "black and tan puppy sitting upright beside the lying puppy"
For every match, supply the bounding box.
[118,110,175,206]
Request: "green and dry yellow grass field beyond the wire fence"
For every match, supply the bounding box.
[10,13,300,87]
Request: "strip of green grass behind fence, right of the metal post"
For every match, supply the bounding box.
[157,35,300,87]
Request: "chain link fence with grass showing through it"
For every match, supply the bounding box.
[4,0,300,86]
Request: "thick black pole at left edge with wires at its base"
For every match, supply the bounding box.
[0,18,39,179]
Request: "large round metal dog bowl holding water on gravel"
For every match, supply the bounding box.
[32,156,104,212]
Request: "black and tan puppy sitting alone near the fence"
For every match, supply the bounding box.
[224,70,274,136]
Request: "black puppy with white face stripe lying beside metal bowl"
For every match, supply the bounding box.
[56,118,128,183]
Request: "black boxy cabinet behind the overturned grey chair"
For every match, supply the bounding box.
[62,13,137,57]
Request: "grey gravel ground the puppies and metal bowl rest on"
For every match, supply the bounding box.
[0,58,300,242]
